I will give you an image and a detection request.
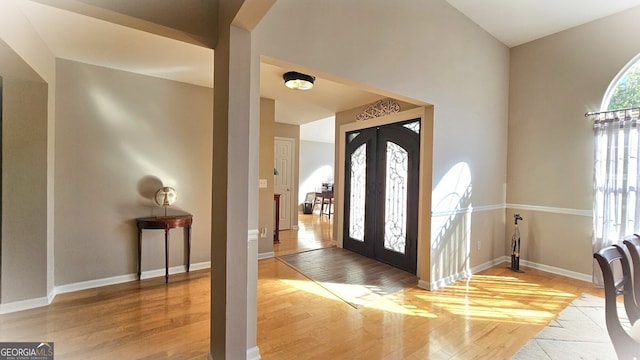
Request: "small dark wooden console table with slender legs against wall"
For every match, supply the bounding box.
[136,214,193,283]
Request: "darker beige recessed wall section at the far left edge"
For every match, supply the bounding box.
[0,78,49,304]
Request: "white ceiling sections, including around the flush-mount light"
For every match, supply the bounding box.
[8,0,640,124]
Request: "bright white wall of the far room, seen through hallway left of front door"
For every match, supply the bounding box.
[297,140,335,205]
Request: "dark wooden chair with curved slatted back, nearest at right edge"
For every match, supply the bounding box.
[593,245,640,359]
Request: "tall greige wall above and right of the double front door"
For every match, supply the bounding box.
[255,0,509,286]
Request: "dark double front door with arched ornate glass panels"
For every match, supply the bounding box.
[343,119,420,274]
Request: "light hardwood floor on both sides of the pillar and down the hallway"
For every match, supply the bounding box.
[0,215,603,360]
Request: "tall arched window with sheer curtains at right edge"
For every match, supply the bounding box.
[593,55,640,285]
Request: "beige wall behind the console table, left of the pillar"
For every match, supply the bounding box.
[55,59,213,285]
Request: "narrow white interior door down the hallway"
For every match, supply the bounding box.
[273,137,295,230]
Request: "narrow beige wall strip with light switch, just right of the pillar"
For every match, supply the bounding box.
[258,98,275,254]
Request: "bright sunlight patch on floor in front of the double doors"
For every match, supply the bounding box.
[280,275,575,324]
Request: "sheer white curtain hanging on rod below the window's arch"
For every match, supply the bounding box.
[592,108,640,287]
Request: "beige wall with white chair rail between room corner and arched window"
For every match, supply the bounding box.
[505,8,640,279]
